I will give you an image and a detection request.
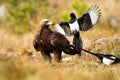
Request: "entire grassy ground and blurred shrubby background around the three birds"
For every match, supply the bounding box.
[0,0,120,80]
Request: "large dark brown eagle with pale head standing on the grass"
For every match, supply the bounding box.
[33,19,77,62]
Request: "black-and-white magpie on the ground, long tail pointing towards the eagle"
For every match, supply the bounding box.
[82,49,120,66]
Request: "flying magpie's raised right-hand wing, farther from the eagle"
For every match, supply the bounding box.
[78,5,101,31]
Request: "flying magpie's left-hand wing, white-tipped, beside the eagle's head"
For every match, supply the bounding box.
[55,22,71,35]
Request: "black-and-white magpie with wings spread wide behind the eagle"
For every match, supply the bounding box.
[55,5,101,54]
